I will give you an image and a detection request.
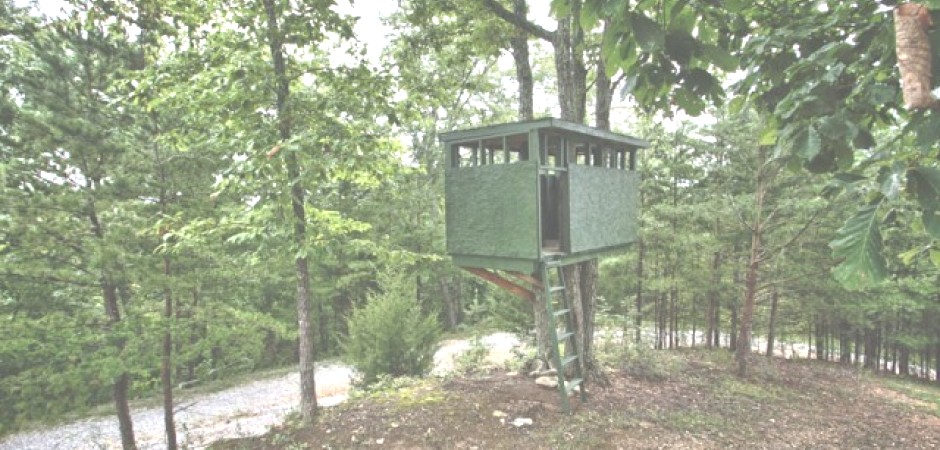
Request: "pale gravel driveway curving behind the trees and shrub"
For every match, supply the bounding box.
[0,333,520,450]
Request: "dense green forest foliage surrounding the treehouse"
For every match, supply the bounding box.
[0,0,940,444]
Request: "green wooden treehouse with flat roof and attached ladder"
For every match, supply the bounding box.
[441,118,649,411]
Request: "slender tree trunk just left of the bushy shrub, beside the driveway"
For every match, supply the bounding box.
[263,0,317,423]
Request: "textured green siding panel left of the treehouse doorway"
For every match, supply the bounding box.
[445,161,539,260]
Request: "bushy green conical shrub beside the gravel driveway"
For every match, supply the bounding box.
[342,273,441,384]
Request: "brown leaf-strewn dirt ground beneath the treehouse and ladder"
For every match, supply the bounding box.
[214,351,940,449]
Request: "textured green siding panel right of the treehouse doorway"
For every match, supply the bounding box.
[568,165,640,253]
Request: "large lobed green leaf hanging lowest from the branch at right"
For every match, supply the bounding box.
[829,204,887,289]
